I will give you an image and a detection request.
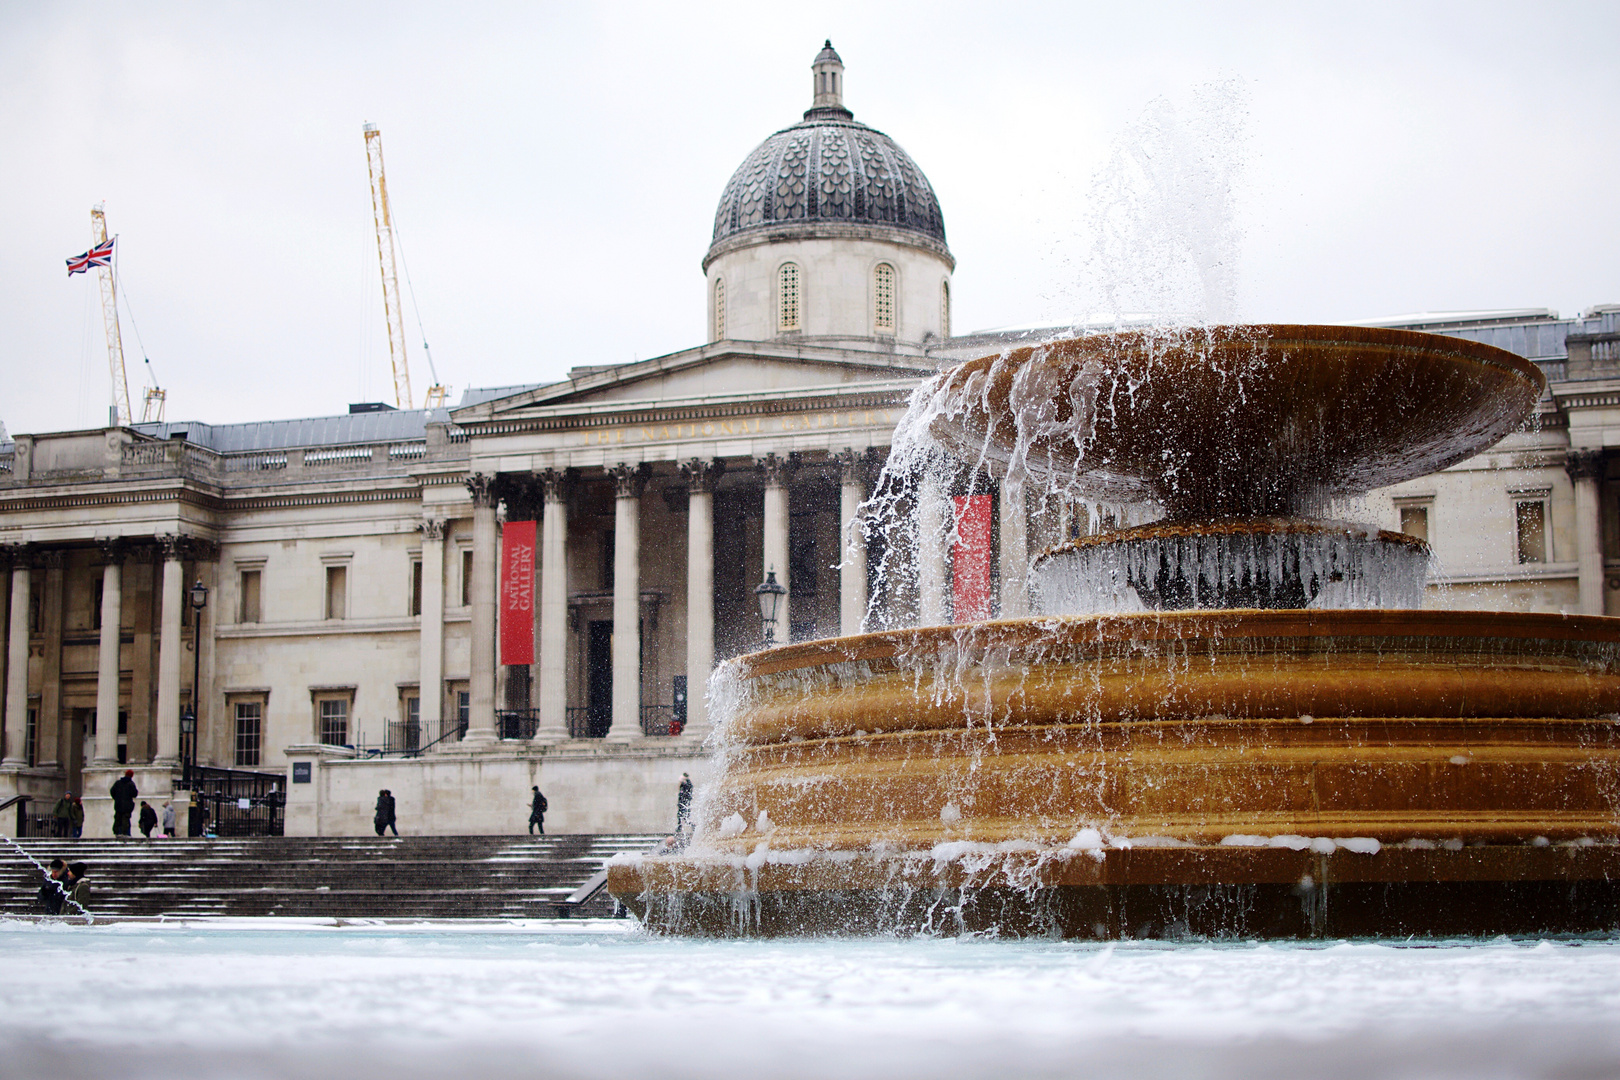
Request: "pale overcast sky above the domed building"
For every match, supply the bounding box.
[0,0,1620,432]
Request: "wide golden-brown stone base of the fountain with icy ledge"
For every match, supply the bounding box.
[609,610,1620,936]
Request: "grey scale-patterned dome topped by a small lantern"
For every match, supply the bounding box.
[710,42,948,256]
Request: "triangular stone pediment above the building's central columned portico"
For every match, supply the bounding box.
[450,342,935,424]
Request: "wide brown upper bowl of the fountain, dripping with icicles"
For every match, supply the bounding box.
[928,325,1547,520]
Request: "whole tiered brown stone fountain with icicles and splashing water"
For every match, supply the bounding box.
[609,325,1620,938]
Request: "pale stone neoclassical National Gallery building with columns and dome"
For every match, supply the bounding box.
[9,45,1620,836]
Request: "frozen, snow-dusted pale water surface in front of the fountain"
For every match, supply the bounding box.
[0,920,1620,1080]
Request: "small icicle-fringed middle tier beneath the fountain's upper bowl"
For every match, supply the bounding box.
[1030,518,1429,615]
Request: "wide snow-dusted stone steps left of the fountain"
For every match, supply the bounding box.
[0,834,661,918]
